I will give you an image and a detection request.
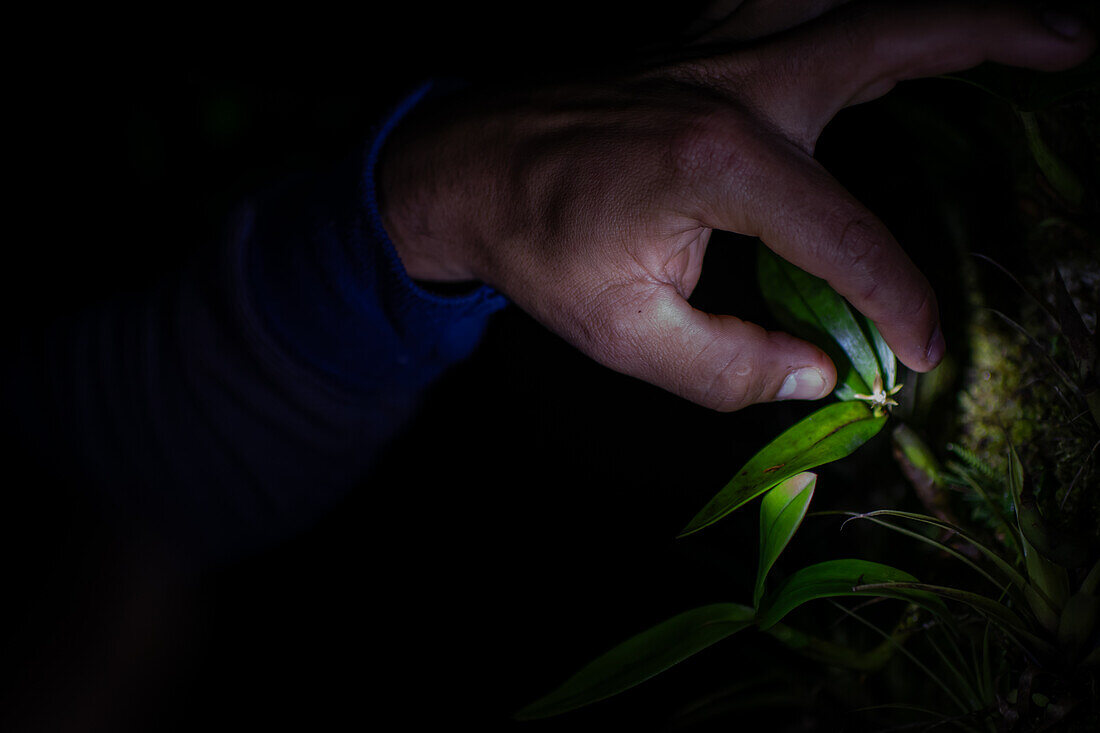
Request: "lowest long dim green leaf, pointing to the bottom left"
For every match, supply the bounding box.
[516,603,756,720]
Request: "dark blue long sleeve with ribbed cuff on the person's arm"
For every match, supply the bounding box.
[3,86,505,562]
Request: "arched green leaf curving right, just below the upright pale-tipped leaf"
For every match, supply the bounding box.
[758,559,927,630]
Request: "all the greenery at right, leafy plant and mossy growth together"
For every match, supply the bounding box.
[519,47,1100,733]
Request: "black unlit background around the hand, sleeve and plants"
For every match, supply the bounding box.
[2,1,1078,731]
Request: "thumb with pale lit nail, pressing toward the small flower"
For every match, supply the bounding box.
[582,285,836,412]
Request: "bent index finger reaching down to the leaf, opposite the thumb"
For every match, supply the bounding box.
[694,122,945,372]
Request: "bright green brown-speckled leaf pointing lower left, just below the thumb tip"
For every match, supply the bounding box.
[680,402,887,537]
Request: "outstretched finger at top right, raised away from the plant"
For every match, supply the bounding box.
[713,0,1096,150]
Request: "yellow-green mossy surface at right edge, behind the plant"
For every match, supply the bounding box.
[957,93,1100,541]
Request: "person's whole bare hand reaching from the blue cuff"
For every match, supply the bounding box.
[377,0,1096,411]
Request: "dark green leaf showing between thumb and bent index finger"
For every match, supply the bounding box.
[757,244,873,401]
